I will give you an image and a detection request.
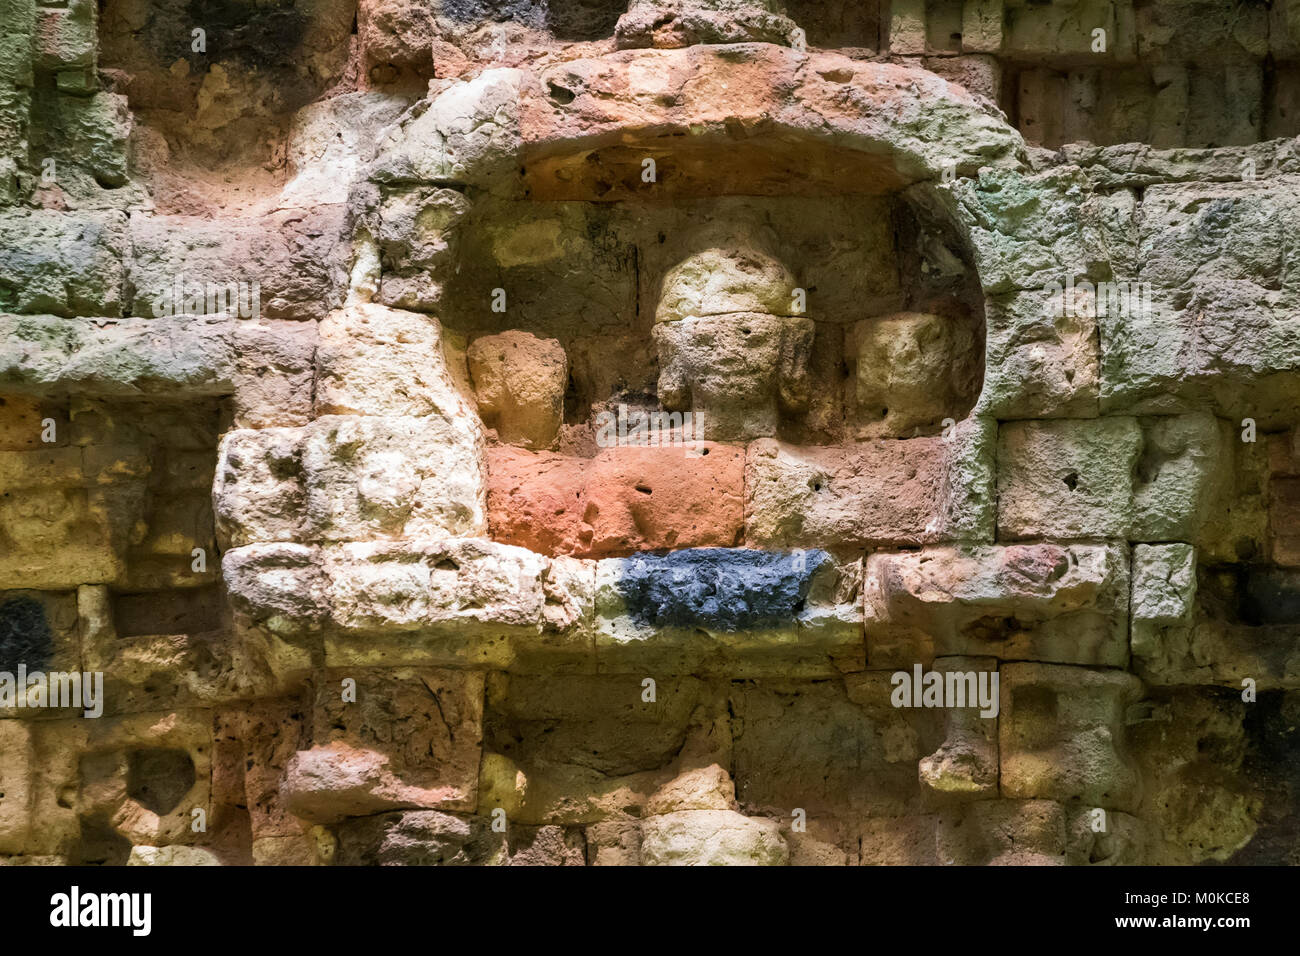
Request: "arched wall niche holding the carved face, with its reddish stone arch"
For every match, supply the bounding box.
[366,44,1021,557]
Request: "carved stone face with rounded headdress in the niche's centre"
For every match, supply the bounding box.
[654,238,814,441]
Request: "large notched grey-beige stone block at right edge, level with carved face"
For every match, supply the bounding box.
[1100,179,1300,428]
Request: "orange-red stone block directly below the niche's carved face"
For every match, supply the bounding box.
[488,444,745,558]
